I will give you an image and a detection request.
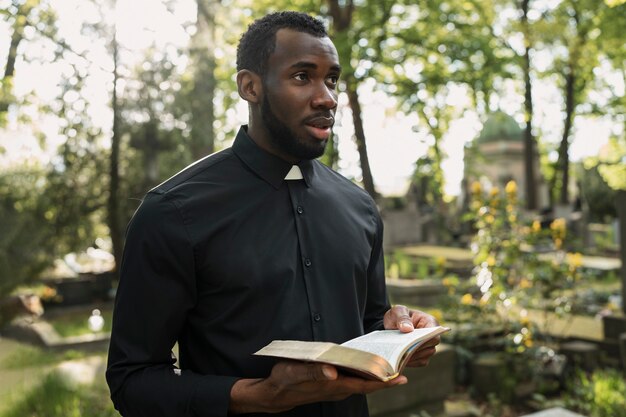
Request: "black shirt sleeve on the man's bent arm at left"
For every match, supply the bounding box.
[106,194,237,417]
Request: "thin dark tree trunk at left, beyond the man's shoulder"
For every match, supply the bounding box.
[107,29,124,272]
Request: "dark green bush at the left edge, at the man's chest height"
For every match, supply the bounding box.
[0,158,101,297]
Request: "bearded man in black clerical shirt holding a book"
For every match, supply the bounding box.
[107,12,438,417]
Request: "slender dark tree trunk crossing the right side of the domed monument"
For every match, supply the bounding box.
[521,0,537,210]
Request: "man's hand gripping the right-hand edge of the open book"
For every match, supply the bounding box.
[384,305,441,366]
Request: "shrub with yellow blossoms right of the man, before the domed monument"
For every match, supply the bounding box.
[446,181,581,353]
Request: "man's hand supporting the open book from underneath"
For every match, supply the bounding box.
[229,361,407,414]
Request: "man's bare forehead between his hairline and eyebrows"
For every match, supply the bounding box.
[269,29,339,71]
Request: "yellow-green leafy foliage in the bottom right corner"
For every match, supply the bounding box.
[565,369,626,417]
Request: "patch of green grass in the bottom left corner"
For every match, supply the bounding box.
[0,372,119,417]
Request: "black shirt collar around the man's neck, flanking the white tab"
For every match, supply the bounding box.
[233,125,313,189]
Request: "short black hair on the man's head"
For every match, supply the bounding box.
[237,11,328,77]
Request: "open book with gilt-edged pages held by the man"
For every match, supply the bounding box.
[255,326,450,381]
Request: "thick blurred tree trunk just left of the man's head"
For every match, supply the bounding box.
[190,0,220,160]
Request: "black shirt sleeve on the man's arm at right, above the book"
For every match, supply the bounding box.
[363,207,391,333]
